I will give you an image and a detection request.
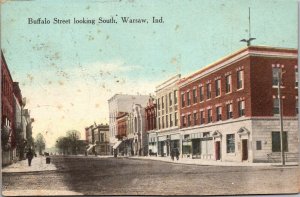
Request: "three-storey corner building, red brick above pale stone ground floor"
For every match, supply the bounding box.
[178,46,298,162]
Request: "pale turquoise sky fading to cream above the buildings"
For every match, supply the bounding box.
[1,0,297,147]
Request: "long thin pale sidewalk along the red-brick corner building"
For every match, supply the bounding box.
[128,156,299,167]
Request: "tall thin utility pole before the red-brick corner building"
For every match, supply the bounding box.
[278,68,285,166]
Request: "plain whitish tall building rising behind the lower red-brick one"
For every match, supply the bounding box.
[108,94,149,154]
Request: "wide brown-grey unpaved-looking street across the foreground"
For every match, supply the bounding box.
[2,156,298,195]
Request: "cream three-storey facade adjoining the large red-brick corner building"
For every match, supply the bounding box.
[148,75,181,156]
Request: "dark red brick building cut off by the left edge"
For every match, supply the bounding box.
[1,51,16,165]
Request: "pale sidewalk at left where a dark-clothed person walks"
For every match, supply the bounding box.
[2,156,56,172]
